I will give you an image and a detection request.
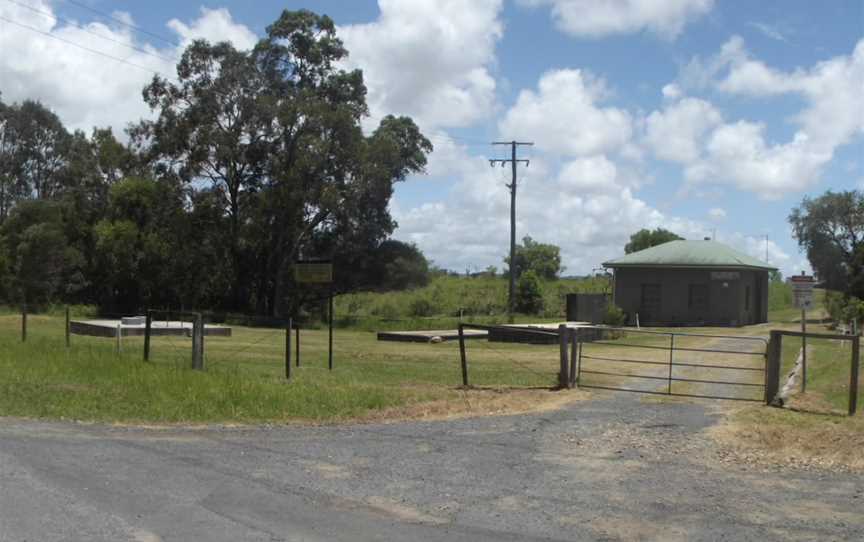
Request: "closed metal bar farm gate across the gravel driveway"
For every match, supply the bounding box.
[571,327,768,402]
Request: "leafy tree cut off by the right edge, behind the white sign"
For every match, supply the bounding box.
[789,190,864,299]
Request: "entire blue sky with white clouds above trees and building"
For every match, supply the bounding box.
[0,0,864,275]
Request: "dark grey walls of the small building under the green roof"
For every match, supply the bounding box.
[614,268,768,326]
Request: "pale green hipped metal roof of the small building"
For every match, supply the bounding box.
[603,241,777,270]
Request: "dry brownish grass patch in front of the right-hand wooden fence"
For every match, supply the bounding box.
[711,407,864,471]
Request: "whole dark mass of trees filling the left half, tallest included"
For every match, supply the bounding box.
[0,11,432,316]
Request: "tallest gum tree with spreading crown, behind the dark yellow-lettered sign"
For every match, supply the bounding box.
[132,10,432,315]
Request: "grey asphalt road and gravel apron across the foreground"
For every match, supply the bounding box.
[0,393,864,542]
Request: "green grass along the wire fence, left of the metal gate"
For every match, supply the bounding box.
[0,315,558,422]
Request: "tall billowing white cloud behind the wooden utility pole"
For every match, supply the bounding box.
[391,76,705,273]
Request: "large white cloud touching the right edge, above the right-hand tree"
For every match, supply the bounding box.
[646,36,864,199]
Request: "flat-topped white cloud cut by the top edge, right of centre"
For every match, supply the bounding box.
[522,0,714,39]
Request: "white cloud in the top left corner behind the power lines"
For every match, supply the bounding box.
[0,1,254,134]
